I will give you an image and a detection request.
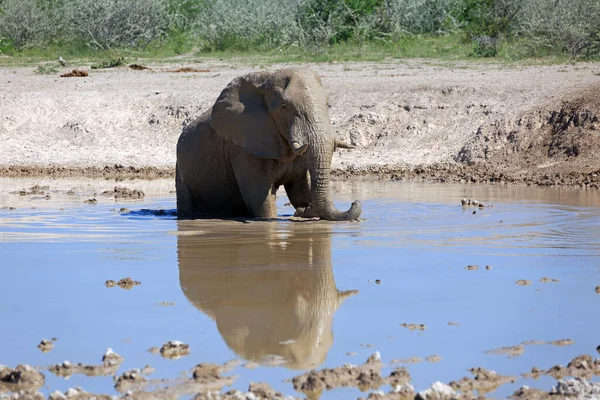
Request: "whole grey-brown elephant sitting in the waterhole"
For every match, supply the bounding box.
[175,69,362,221]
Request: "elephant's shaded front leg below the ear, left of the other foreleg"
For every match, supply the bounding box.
[231,155,277,218]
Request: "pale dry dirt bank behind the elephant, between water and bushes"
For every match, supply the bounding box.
[0,60,600,188]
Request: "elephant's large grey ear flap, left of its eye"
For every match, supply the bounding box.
[210,77,287,159]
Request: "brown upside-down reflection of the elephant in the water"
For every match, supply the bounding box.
[177,221,357,369]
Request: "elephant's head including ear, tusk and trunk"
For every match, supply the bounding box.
[211,69,362,220]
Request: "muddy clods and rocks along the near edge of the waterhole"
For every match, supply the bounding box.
[0,354,600,400]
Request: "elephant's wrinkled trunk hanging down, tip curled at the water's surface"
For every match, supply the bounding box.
[300,135,362,221]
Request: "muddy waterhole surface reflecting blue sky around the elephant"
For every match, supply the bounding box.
[0,180,600,399]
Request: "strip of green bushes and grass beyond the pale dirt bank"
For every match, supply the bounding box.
[0,0,600,58]
